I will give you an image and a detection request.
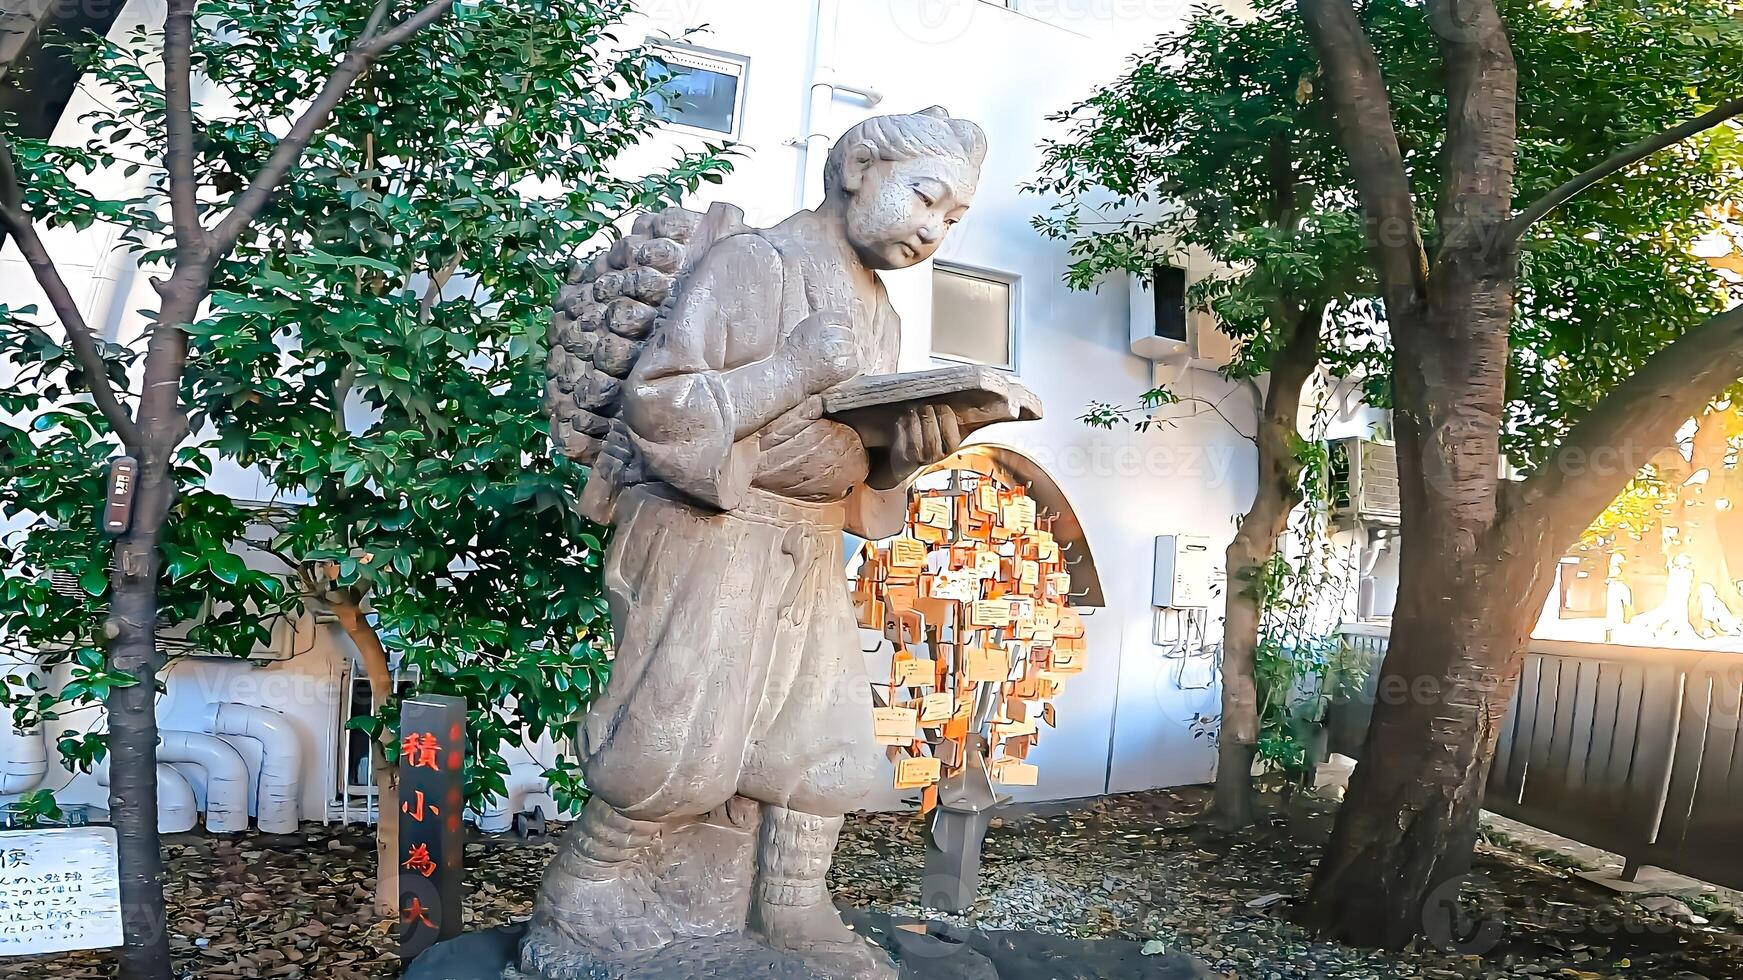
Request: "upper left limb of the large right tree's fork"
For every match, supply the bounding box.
[1297,0,1428,310]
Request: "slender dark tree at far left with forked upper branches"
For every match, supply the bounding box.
[0,0,456,980]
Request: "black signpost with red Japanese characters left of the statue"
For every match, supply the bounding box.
[399,694,465,961]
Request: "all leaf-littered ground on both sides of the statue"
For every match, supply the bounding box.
[0,792,1743,980]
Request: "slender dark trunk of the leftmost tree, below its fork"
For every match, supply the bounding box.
[105,452,173,980]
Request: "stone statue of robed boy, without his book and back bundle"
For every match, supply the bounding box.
[521,108,987,978]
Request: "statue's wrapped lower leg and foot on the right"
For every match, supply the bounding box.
[749,806,896,980]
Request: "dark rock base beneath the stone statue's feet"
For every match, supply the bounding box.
[404,912,1215,980]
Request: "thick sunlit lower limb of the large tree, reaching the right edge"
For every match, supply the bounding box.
[1508,307,1743,555]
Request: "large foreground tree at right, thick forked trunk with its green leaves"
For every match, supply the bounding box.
[1297,0,1743,947]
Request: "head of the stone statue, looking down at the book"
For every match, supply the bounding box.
[823,106,987,269]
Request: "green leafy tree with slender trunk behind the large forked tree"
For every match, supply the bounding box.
[1035,0,1738,847]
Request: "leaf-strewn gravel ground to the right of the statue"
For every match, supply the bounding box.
[837,790,1743,980]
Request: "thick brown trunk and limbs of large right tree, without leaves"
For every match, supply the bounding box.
[1297,0,1743,949]
